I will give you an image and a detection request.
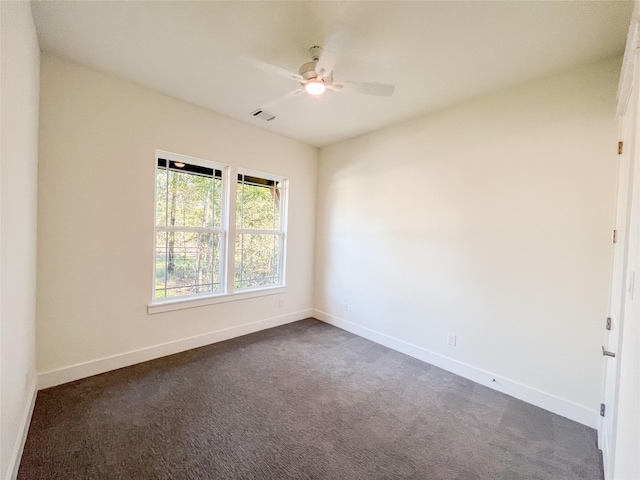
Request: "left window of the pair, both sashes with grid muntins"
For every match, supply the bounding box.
[154,155,225,301]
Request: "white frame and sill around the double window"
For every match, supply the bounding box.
[147,150,288,315]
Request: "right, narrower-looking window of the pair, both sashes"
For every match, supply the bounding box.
[234,170,284,290]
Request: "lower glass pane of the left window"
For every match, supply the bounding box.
[156,232,220,298]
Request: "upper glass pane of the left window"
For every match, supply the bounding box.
[165,170,221,227]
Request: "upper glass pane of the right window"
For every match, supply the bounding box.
[236,178,280,230]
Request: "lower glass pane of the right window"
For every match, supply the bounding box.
[235,234,280,289]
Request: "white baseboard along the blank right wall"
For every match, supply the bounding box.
[313,310,598,428]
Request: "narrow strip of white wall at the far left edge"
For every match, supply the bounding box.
[0,2,40,479]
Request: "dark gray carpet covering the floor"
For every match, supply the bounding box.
[18,319,602,480]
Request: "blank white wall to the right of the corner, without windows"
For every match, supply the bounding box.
[315,59,620,426]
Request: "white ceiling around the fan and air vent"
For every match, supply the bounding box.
[32,1,633,147]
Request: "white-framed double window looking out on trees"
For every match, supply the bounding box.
[152,151,286,303]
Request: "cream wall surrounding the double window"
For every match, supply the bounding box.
[37,55,318,386]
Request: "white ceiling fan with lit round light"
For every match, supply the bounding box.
[245,45,395,108]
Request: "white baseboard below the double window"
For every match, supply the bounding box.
[38,310,313,390]
